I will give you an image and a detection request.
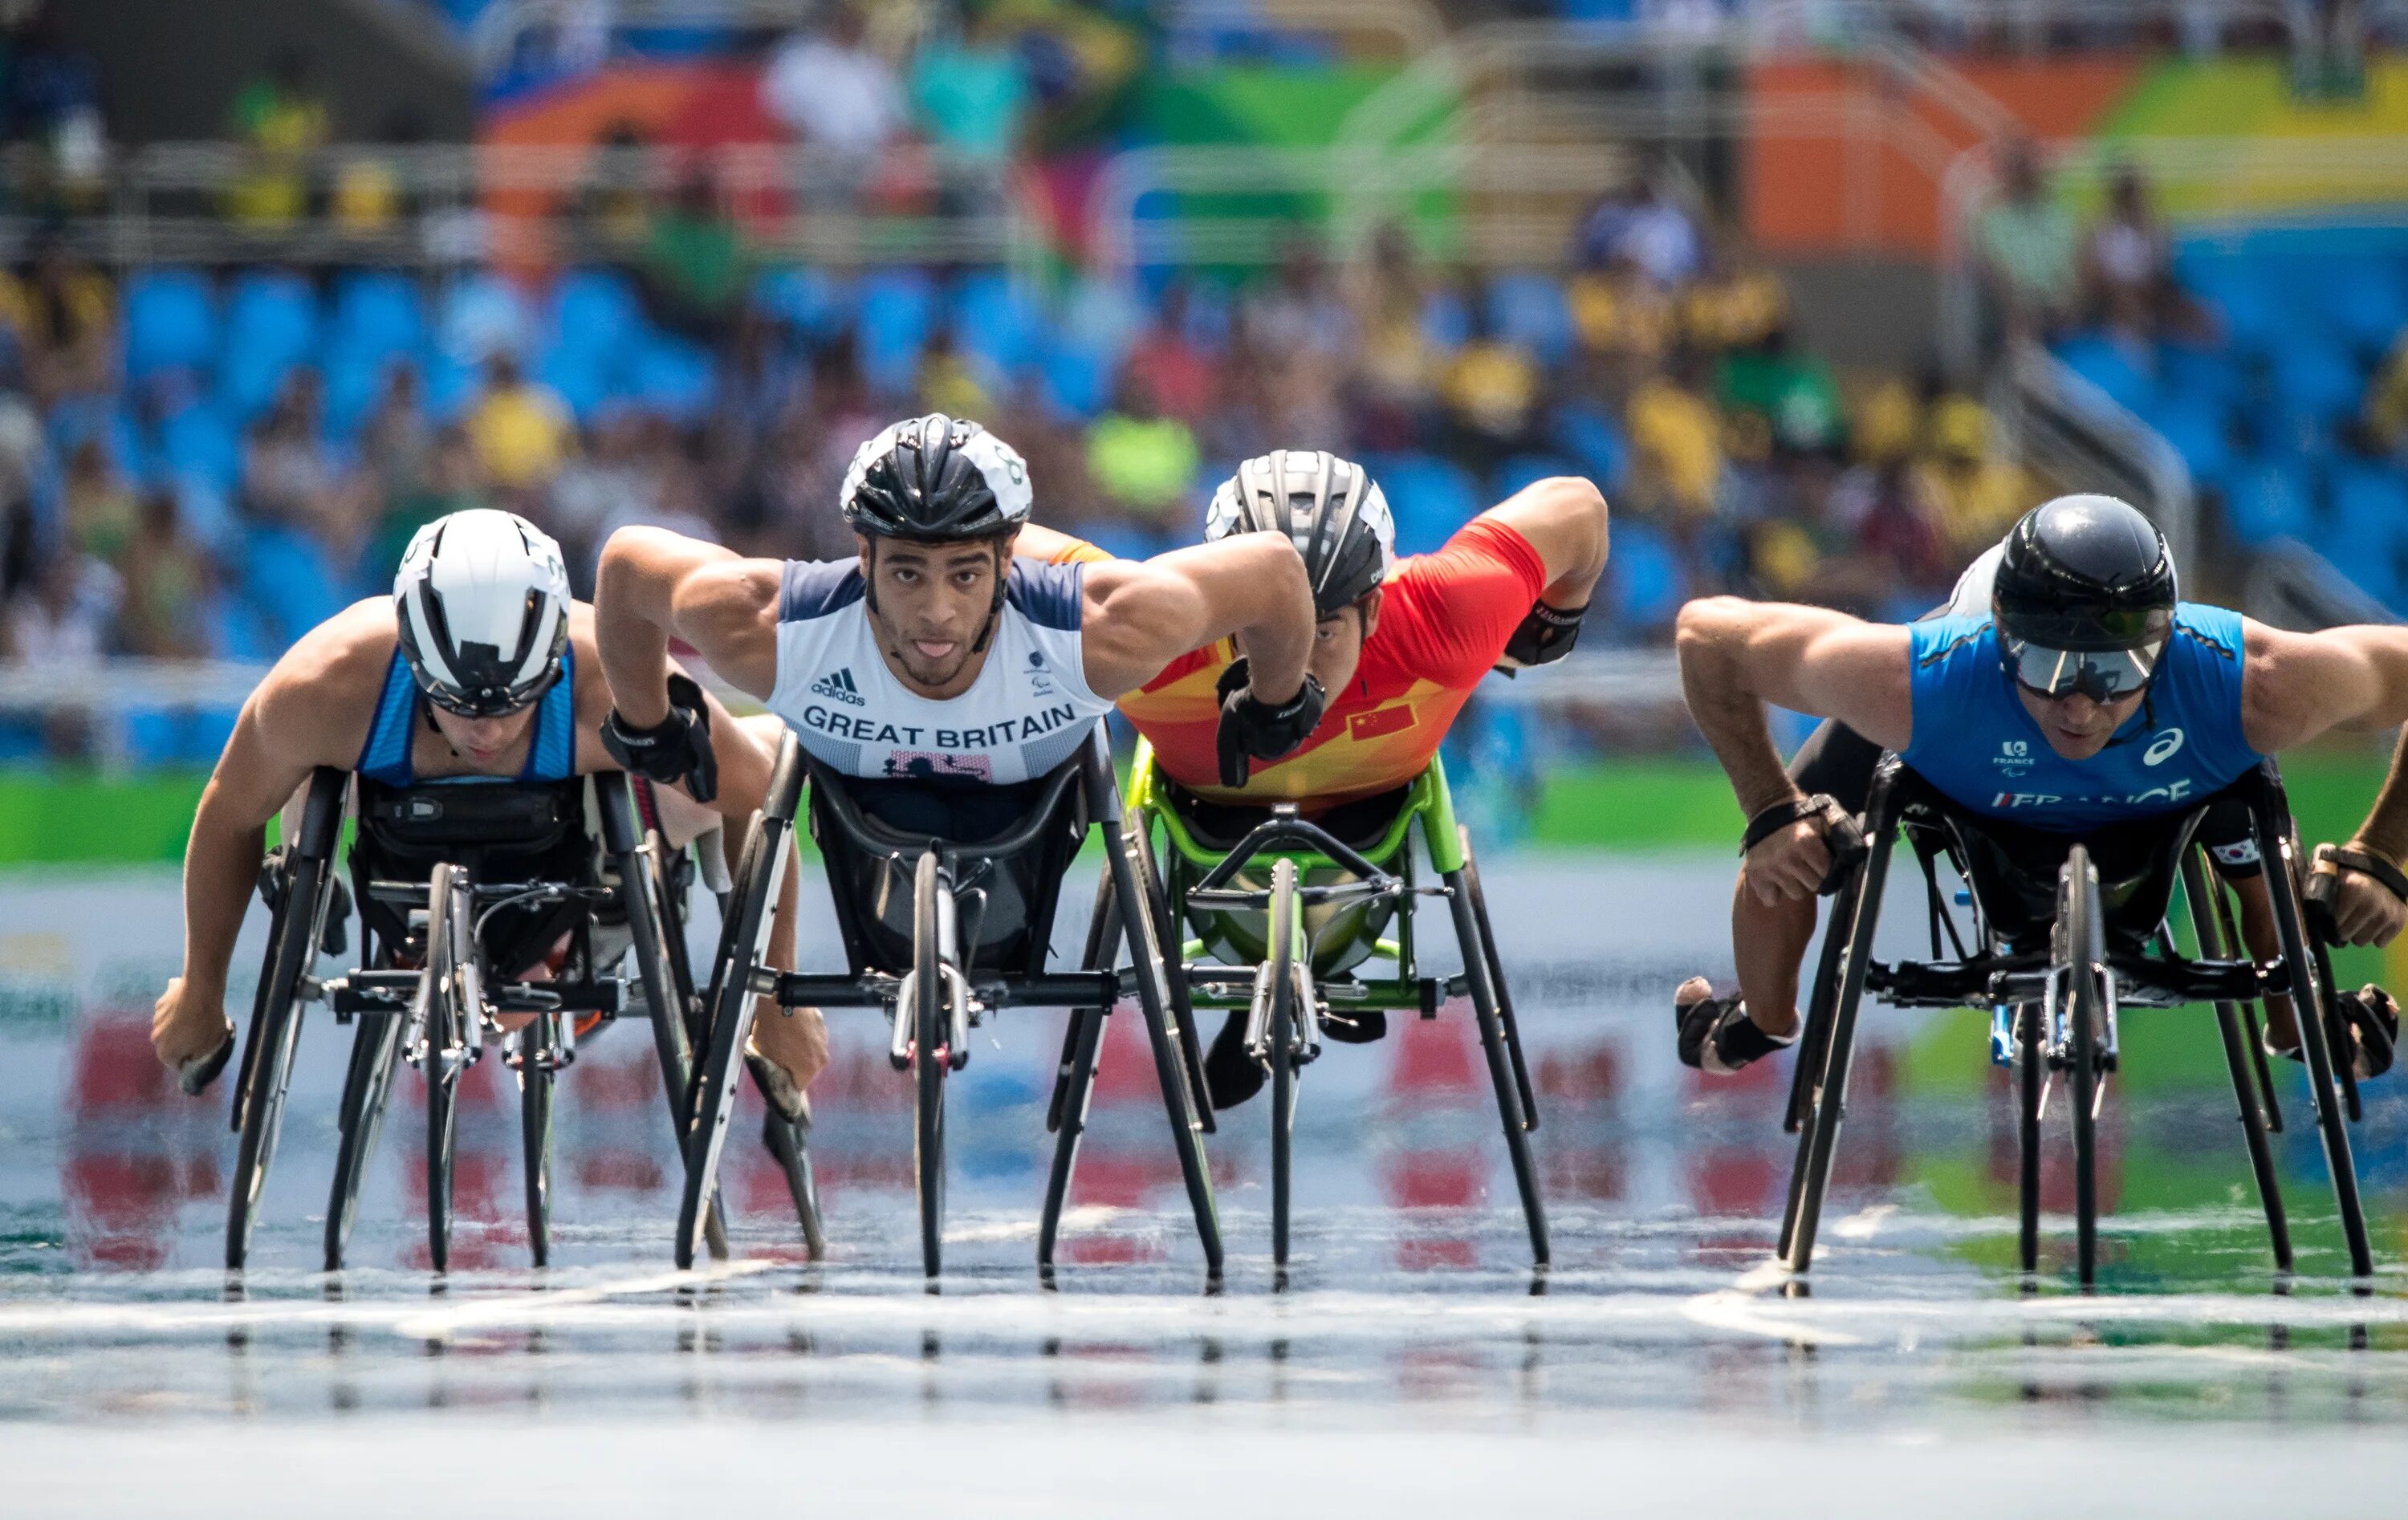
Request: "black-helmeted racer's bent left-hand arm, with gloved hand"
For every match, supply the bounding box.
[1678,597,1914,904]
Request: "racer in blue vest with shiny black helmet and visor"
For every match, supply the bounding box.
[1676,496,2408,1077]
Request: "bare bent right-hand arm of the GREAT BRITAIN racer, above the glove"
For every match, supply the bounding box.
[1081,532,1312,705]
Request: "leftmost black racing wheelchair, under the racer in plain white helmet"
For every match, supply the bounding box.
[226,766,816,1272]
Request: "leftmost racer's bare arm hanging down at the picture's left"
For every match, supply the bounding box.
[152,597,393,1067]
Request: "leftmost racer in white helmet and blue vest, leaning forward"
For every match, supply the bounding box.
[152,508,826,1118]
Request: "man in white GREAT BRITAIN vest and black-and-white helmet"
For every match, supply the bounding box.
[595,412,1324,891]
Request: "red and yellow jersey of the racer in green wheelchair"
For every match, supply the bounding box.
[1069,518,1546,805]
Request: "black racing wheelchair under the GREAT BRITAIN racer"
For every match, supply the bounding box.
[677,722,1221,1279]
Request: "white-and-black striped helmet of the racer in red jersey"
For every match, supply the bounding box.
[1204,450,1397,616]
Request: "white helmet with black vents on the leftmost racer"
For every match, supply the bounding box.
[393,506,568,717]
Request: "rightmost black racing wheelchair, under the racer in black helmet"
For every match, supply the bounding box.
[1777,754,2374,1289]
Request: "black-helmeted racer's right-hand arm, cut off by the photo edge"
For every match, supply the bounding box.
[2242,621,2408,945]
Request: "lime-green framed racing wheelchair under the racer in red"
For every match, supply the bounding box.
[1052,742,1548,1270]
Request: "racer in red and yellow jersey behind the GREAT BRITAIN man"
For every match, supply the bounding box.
[1021,450,1606,1108]
